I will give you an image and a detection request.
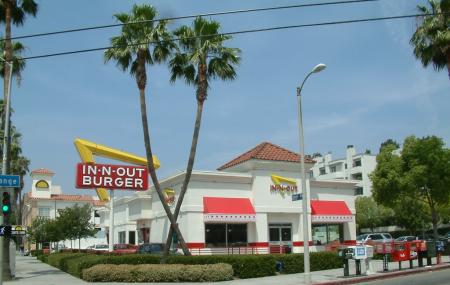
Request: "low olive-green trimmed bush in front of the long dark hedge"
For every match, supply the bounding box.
[83,263,233,282]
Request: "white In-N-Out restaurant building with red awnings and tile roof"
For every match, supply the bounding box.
[109,143,356,254]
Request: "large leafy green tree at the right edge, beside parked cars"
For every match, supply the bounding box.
[371,136,450,239]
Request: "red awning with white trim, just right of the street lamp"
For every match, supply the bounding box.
[311,200,353,223]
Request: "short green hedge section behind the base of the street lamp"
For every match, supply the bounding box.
[275,252,342,274]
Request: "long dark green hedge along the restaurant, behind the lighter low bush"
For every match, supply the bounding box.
[44,252,342,279]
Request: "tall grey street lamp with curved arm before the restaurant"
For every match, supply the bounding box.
[297,63,326,284]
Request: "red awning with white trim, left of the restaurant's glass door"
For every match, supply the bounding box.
[203,197,256,222]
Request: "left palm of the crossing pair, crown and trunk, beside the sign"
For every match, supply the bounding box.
[105,4,190,255]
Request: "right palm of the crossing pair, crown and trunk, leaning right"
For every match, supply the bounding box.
[164,17,240,256]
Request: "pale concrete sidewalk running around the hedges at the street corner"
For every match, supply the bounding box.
[4,252,450,285]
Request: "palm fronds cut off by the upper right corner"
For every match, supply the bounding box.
[410,0,450,77]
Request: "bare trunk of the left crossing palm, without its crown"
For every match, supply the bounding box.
[139,88,191,255]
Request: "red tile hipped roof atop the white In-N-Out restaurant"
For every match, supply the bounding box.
[217,142,314,170]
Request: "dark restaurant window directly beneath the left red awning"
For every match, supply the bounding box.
[205,224,247,247]
